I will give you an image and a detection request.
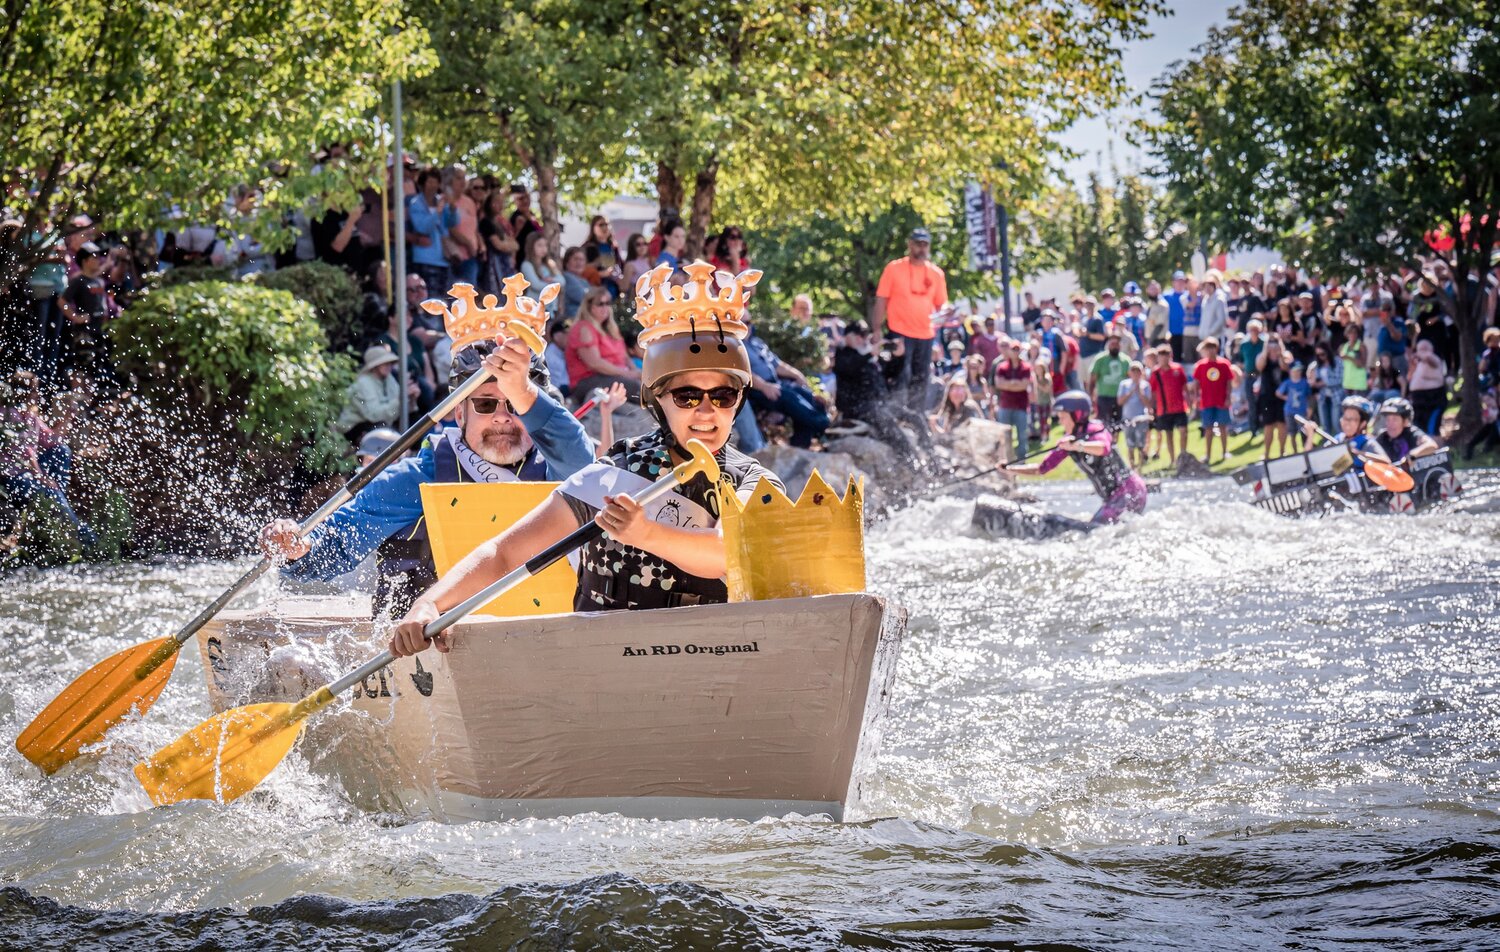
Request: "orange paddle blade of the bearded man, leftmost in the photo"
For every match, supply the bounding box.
[15,637,182,774]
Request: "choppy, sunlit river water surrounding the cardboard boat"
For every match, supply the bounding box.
[0,474,1500,951]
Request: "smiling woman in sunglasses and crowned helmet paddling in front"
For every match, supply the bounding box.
[390,261,785,657]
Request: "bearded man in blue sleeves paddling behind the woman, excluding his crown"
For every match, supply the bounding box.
[261,337,594,618]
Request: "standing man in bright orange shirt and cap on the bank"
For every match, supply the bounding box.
[870,228,948,414]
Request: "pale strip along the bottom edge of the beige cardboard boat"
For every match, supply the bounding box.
[399,787,845,822]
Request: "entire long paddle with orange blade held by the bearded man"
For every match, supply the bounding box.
[15,321,545,774]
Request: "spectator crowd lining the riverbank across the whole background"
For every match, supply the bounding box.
[0,148,1500,557]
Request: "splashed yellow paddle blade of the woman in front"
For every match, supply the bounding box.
[135,687,333,807]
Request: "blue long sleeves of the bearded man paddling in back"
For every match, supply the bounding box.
[281,391,594,582]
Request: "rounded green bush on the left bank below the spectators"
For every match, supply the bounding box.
[110,282,354,472]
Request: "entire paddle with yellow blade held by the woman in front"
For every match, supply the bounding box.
[135,439,719,807]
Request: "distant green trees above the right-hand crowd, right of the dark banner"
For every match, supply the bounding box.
[1013,172,1199,291]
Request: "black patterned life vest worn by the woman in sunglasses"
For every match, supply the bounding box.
[573,430,785,612]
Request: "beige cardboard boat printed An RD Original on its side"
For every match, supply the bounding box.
[198,594,906,820]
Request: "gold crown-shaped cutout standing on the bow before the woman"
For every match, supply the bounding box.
[719,469,864,601]
